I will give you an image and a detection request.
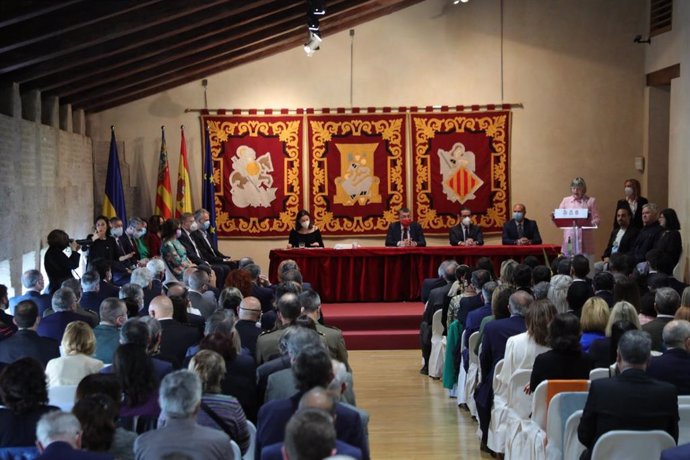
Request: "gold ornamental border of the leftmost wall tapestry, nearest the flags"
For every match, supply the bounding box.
[206,116,302,237]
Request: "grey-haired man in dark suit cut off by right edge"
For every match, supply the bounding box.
[647,320,690,395]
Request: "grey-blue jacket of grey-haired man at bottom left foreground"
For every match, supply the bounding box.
[134,418,234,460]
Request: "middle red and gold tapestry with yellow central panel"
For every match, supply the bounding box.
[307,114,406,236]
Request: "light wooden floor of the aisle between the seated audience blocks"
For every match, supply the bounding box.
[349,350,491,460]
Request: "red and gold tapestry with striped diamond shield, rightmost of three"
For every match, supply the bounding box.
[411,111,510,235]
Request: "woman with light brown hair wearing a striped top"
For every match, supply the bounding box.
[189,350,249,454]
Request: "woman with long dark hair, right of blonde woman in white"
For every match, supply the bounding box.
[112,343,160,419]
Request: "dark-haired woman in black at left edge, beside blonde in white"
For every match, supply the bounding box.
[0,358,60,447]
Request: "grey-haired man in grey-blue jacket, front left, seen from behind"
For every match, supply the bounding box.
[134,370,234,460]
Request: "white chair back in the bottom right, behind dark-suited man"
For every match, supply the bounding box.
[592,430,676,460]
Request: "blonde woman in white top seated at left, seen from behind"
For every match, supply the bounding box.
[46,321,103,387]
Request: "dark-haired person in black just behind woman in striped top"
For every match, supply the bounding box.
[199,329,259,422]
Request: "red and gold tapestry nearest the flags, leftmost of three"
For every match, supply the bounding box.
[202,115,304,238]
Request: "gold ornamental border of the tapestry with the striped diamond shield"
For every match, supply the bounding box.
[411,111,510,233]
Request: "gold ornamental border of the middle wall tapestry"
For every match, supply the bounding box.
[308,114,405,235]
